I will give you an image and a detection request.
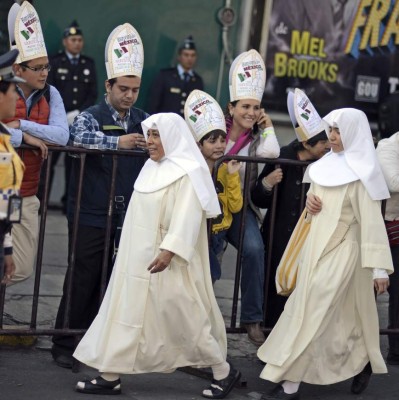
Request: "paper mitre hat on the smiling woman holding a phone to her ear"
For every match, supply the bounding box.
[229,50,266,101]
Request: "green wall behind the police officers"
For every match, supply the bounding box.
[33,0,242,110]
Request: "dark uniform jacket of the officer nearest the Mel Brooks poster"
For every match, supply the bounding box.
[148,67,204,117]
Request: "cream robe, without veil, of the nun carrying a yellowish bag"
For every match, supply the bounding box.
[258,181,393,385]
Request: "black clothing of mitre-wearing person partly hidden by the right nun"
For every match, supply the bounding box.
[252,142,309,326]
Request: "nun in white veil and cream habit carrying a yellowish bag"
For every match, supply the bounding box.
[258,108,393,400]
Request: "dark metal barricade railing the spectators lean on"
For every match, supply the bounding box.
[0,146,399,337]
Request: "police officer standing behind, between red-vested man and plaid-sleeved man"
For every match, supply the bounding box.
[44,21,97,212]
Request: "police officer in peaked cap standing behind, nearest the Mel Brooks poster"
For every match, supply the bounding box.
[148,36,204,117]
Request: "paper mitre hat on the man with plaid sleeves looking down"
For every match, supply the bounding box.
[105,23,144,79]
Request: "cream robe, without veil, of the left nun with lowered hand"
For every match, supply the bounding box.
[74,175,227,374]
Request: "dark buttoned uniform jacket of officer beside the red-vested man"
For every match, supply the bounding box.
[47,51,97,112]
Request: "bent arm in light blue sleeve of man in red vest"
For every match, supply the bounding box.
[19,86,69,146]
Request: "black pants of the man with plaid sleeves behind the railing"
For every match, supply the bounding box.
[53,225,115,355]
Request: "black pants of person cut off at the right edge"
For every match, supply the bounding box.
[388,246,399,357]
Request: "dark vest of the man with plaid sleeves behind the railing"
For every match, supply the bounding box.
[67,100,147,228]
